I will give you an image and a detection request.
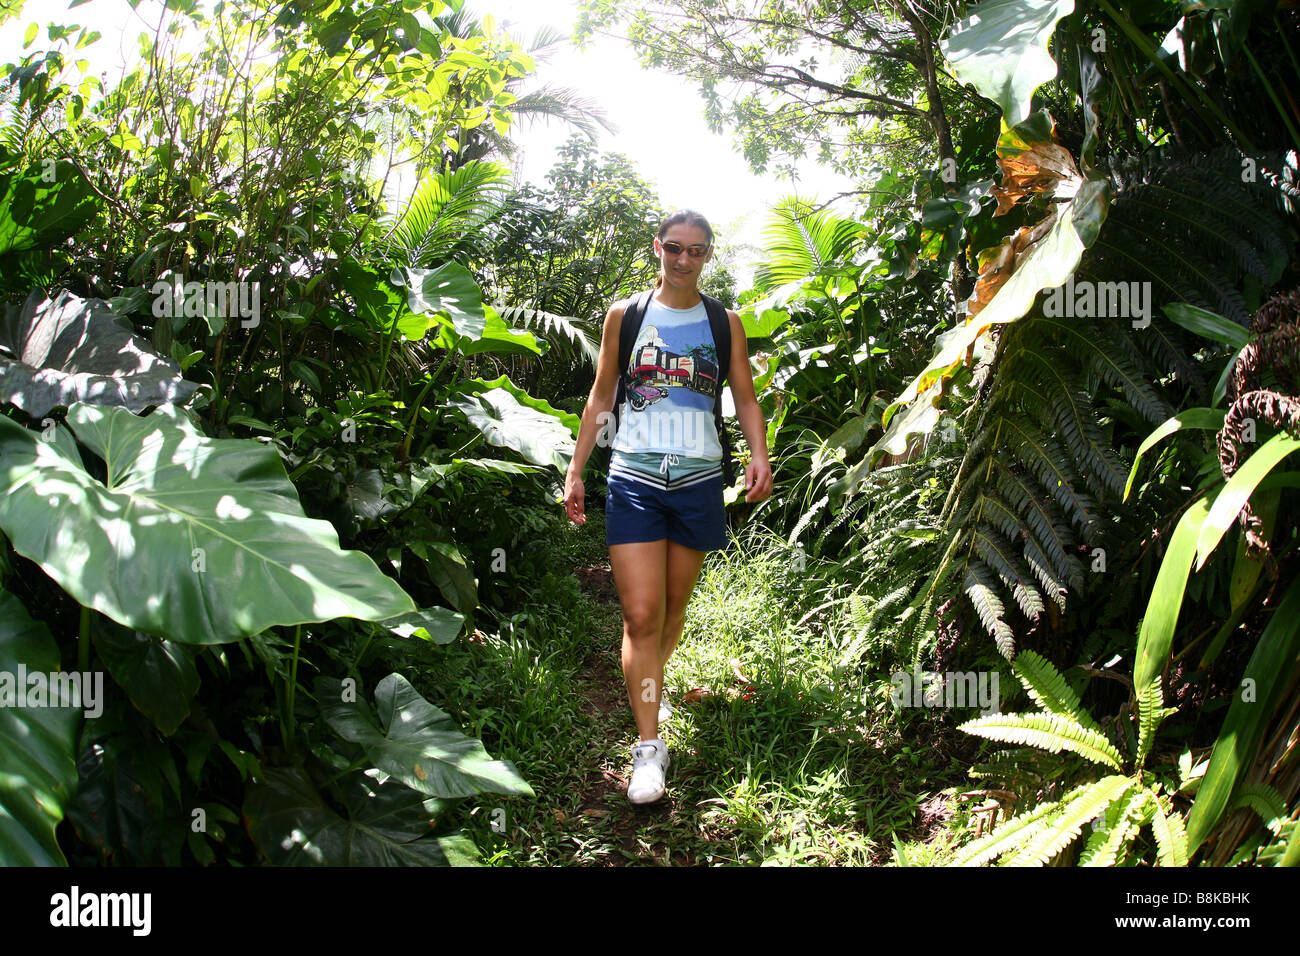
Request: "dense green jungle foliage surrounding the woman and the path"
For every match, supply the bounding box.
[0,0,1300,865]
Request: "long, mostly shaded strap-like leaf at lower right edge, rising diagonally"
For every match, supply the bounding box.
[1187,578,1300,853]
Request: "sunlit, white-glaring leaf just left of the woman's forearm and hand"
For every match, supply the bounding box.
[449,375,581,473]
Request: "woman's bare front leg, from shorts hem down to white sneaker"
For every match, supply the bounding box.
[610,538,670,740]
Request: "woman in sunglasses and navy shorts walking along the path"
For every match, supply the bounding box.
[564,209,772,804]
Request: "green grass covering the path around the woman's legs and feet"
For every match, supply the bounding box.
[390,509,965,866]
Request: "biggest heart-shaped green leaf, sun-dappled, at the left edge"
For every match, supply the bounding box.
[0,405,415,644]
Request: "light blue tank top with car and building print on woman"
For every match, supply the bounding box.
[611,297,723,463]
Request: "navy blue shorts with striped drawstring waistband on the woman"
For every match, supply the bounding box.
[605,466,727,551]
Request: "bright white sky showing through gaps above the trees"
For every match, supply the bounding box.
[0,0,850,274]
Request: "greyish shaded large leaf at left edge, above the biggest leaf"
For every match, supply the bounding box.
[0,291,198,419]
